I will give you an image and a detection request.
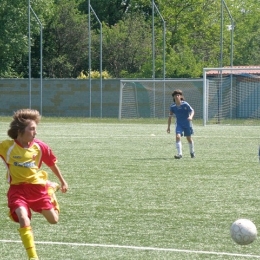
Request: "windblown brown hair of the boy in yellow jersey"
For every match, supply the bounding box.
[7,109,41,139]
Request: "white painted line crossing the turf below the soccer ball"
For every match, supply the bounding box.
[0,240,260,258]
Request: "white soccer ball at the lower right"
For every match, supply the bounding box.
[230,219,257,245]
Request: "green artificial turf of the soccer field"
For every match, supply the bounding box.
[0,118,260,260]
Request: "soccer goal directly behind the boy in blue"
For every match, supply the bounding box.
[118,79,203,119]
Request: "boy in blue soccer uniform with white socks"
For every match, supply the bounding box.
[167,89,195,159]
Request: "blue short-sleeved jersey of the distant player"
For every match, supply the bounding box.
[170,101,193,127]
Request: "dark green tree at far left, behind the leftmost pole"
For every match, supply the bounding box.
[0,0,53,77]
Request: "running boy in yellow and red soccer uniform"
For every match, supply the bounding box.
[0,109,68,260]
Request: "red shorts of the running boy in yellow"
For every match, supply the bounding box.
[7,184,53,222]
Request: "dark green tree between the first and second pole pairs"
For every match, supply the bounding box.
[41,0,88,78]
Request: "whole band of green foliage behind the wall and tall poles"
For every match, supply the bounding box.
[0,0,260,78]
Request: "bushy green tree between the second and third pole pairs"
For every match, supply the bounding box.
[93,15,151,77]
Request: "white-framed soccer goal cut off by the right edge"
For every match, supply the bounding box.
[203,66,260,125]
